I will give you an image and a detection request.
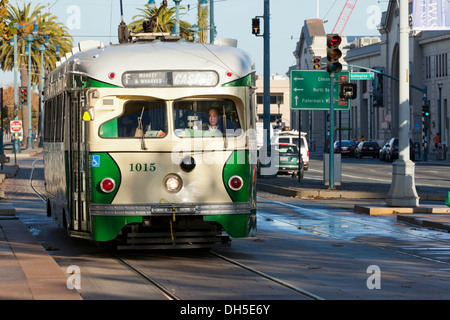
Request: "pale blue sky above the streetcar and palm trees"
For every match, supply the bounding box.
[0,0,389,86]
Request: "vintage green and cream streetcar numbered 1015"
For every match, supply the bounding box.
[44,35,256,248]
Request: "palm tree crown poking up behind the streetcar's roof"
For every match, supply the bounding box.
[128,5,192,40]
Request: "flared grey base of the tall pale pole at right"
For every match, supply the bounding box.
[386,160,419,207]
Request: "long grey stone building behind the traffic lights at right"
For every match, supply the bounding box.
[291,1,450,159]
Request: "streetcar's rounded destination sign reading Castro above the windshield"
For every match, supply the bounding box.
[122,71,219,88]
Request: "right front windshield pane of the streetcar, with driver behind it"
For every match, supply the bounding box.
[173,99,241,137]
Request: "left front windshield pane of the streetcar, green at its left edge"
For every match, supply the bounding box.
[100,100,167,138]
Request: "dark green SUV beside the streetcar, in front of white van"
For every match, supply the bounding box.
[275,143,305,178]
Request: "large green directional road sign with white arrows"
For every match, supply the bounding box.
[290,70,350,111]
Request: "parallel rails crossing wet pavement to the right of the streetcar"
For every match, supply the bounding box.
[258,197,450,265]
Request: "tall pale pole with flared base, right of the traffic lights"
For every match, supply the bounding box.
[386,0,419,207]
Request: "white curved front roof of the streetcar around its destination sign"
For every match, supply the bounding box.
[50,41,255,87]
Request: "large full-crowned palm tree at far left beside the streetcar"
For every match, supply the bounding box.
[0,3,72,146]
